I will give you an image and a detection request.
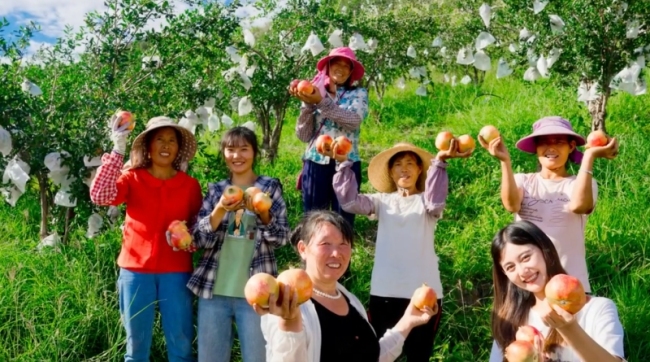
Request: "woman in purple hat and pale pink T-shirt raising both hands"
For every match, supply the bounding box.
[478,116,618,293]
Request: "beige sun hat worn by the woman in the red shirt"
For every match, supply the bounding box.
[124,116,196,172]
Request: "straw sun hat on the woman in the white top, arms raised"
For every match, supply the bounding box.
[368,142,433,193]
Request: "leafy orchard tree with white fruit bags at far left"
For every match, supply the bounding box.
[0,0,210,241]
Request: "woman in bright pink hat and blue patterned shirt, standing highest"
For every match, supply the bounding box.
[289,47,368,232]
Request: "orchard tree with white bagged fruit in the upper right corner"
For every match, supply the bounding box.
[503,0,650,131]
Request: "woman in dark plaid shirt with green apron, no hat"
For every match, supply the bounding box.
[188,127,290,362]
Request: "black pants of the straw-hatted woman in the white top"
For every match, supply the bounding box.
[368,295,442,362]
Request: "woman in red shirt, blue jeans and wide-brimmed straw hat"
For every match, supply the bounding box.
[90,115,202,361]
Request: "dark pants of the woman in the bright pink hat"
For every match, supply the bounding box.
[302,160,361,279]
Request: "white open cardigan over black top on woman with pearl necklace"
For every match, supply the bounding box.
[261,284,404,362]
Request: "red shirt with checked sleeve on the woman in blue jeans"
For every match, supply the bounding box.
[90,152,202,273]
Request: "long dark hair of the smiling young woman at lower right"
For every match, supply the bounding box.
[491,220,566,358]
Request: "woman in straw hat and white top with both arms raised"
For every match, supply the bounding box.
[326,140,472,362]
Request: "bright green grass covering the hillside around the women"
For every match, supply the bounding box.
[0,76,650,362]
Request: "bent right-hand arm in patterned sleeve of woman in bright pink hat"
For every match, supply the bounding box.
[316,88,368,131]
